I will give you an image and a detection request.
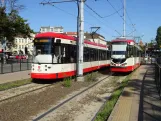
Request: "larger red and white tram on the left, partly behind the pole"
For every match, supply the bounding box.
[31,32,110,79]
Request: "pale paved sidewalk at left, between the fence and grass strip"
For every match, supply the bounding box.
[0,70,30,84]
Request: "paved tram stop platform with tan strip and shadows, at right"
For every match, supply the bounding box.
[107,64,161,121]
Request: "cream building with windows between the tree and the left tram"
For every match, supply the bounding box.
[12,34,36,55]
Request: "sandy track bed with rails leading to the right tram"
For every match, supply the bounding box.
[32,73,126,121]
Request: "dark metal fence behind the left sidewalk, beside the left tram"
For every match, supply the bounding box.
[0,57,33,74]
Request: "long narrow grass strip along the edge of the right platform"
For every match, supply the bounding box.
[95,71,135,121]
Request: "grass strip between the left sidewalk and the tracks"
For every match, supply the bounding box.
[0,79,32,91]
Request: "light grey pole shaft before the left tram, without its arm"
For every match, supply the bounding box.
[77,0,84,81]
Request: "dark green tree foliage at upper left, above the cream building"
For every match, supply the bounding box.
[0,7,34,42]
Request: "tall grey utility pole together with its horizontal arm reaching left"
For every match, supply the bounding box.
[40,0,85,81]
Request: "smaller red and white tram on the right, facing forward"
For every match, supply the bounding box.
[110,38,142,72]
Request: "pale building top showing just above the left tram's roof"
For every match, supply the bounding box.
[40,26,64,33]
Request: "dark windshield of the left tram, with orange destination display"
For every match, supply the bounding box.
[34,38,52,55]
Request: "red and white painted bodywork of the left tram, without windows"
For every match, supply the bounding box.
[31,33,110,79]
